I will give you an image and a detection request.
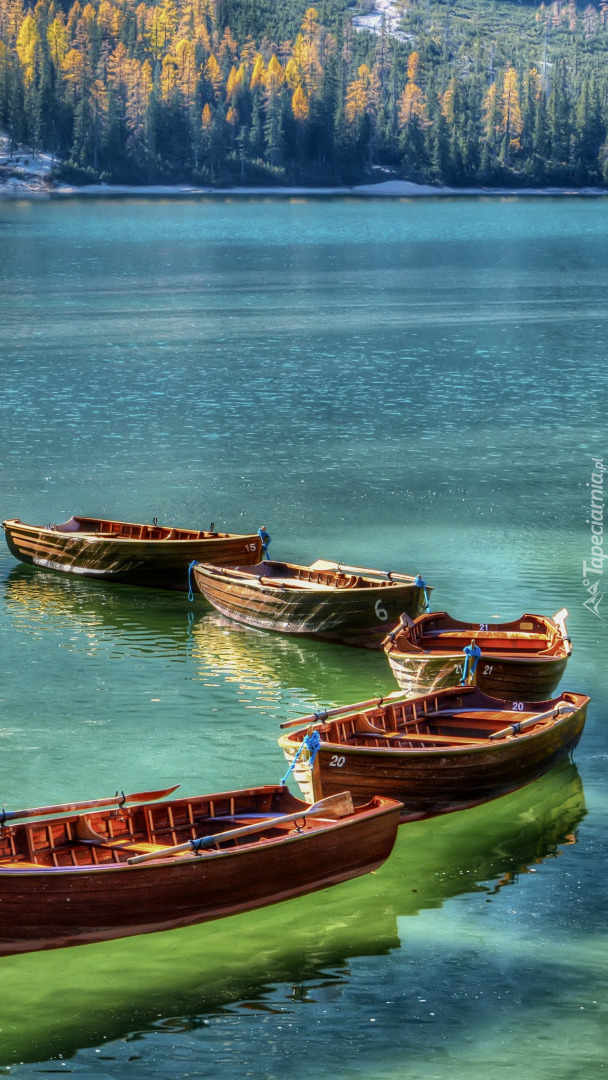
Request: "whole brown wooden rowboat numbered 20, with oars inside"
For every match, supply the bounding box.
[279,686,589,821]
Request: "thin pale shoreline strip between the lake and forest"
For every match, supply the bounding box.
[0,178,608,201]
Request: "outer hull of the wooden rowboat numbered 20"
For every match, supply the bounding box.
[279,688,589,821]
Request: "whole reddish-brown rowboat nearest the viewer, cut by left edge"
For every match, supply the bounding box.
[0,785,401,956]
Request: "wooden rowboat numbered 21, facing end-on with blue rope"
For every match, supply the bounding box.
[383,608,572,701]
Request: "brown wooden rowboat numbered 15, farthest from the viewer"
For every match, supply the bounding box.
[2,516,261,592]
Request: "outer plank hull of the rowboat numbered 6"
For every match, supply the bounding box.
[192,566,425,649]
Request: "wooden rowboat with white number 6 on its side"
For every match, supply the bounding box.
[192,559,431,649]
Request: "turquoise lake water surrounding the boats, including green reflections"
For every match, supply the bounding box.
[0,199,608,1080]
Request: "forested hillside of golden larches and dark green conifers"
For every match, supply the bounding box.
[0,0,608,187]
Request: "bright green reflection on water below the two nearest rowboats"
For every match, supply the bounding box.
[0,764,585,1065]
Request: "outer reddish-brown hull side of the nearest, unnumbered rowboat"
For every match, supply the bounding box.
[0,789,400,956]
